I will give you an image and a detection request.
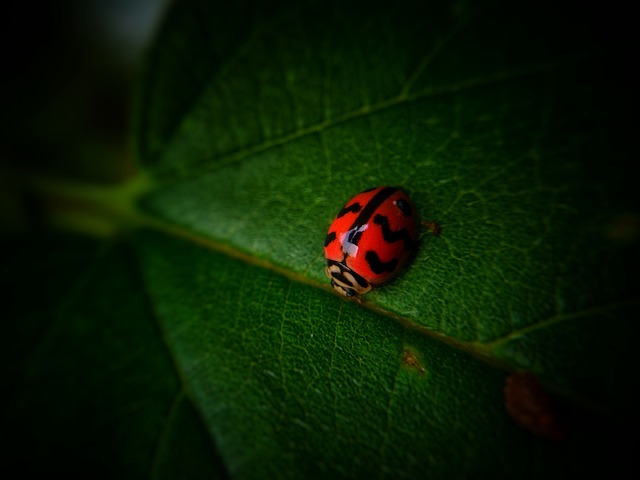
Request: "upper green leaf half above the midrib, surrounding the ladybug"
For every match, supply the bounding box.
[141,2,638,416]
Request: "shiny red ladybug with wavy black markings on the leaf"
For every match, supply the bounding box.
[324,187,438,297]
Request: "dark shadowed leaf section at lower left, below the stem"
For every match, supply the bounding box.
[0,235,226,478]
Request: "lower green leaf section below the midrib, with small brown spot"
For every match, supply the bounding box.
[134,229,624,478]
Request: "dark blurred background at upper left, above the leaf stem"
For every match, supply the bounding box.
[0,0,168,202]
